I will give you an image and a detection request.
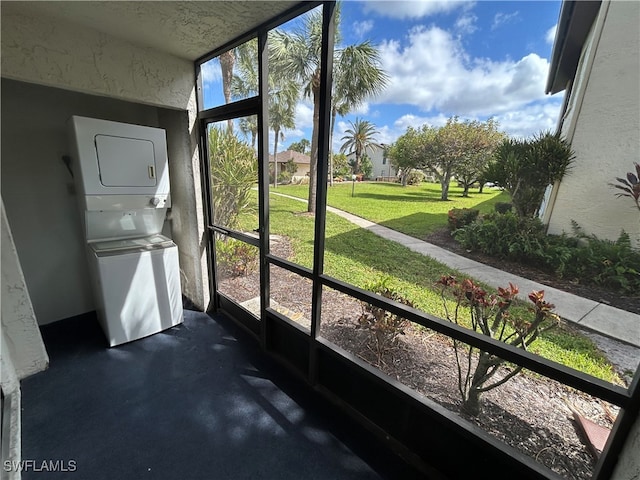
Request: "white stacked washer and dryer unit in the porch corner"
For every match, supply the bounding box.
[68,116,183,347]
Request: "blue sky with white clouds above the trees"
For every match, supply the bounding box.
[202,0,563,151]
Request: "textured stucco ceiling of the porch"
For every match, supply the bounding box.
[2,0,299,60]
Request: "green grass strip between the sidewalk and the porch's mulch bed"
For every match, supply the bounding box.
[238,193,619,382]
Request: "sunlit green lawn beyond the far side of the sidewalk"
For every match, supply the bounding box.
[272,182,509,239]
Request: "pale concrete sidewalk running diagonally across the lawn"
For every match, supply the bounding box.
[271,192,640,347]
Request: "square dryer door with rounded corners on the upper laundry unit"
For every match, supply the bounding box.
[95,135,157,187]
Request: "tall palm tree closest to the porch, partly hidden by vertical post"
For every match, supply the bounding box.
[270,4,386,213]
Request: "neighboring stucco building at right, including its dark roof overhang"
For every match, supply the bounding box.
[542,1,640,247]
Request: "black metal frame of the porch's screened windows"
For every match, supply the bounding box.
[195,1,640,480]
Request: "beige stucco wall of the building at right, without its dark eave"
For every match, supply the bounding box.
[549,2,640,247]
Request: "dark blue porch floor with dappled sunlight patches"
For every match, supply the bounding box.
[22,311,428,480]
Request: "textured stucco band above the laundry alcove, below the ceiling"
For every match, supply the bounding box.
[2,9,195,110]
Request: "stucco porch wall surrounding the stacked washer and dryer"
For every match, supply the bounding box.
[2,6,208,324]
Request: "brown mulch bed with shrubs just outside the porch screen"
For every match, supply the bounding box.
[219,238,618,480]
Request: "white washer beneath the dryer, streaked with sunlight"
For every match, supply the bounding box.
[88,234,183,347]
